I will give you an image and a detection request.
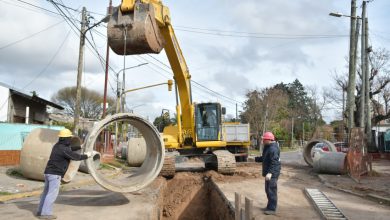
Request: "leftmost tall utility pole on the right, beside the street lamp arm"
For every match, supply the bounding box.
[347,0,357,133]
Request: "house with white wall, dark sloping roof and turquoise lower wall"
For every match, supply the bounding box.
[0,82,64,166]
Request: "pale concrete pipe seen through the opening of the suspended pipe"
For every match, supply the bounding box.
[127,137,146,167]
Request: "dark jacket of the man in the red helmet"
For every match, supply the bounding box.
[262,142,281,178]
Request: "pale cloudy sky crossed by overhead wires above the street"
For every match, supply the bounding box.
[0,0,390,122]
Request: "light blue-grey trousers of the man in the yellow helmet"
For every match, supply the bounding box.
[37,174,61,215]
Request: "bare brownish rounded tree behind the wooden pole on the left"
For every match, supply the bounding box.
[51,87,115,119]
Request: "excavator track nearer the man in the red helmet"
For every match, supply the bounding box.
[212,150,236,175]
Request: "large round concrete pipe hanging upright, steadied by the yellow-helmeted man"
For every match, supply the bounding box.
[85,113,165,192]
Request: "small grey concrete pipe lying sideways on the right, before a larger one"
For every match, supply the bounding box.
[313,149,347,174]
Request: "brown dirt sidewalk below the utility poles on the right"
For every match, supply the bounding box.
[318,159,390,205]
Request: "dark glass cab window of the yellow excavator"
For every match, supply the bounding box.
[195,103,221,141]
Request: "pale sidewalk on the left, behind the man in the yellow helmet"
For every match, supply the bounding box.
[0,166,95,203]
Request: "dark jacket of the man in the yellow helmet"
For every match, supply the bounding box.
[45,138,88,177]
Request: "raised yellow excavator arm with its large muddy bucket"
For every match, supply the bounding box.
[107,0,195,147]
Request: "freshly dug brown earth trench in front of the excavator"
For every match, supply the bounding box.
[158,172,234,220]
